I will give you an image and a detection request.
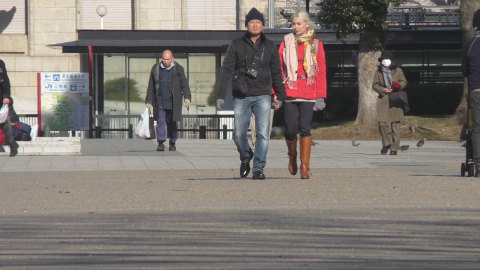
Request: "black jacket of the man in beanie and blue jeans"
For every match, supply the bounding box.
[217,32,285,101]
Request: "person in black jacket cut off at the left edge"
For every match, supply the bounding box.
[0,59,18,157]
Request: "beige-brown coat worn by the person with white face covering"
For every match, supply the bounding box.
[372,68,407,123]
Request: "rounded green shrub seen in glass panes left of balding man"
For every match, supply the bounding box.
[104,77,145,101]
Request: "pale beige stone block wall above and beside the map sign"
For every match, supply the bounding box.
[0,0,80,114]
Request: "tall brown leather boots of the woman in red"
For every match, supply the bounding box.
[286,136,312,179]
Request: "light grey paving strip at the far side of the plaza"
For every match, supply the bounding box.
[0,139,465,176]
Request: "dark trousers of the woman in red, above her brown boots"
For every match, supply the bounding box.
[285,102,315,141]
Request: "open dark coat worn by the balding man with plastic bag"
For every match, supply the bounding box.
[145,62,192,121]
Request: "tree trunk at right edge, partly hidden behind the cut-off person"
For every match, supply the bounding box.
[448,0,480,124]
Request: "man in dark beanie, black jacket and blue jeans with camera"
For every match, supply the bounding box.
[217,8,285,179]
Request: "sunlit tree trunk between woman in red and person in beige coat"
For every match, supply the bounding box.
[354,27,385,135]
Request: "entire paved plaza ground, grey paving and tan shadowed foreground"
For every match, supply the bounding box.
[0,139,480,269]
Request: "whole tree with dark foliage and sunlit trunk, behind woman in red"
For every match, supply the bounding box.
[317,0,405,132]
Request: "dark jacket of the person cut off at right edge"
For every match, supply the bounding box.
[462,33,480,91]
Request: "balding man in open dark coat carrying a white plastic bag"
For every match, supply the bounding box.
[145,50,192,151]
